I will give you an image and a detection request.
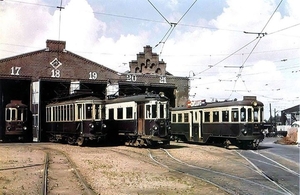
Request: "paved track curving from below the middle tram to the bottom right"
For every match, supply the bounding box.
[149,149,287,194]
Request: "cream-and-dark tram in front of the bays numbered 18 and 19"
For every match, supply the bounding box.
[46,96,107,146]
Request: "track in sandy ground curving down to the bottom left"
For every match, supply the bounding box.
[41,148,96,195]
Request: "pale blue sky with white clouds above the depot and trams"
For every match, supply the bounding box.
[0,0,300,118]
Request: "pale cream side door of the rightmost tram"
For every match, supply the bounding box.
[190,110,202,142]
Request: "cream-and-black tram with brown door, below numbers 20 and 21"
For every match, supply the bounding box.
[105,93,170,147]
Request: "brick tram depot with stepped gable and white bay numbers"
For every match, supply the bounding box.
[0,40,189,141]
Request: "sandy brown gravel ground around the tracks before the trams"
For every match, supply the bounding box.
[0,143,242,195]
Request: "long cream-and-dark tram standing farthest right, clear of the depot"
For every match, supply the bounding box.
[171,96,264,149]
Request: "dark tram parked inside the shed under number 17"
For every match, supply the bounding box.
[4,100,32,142]
